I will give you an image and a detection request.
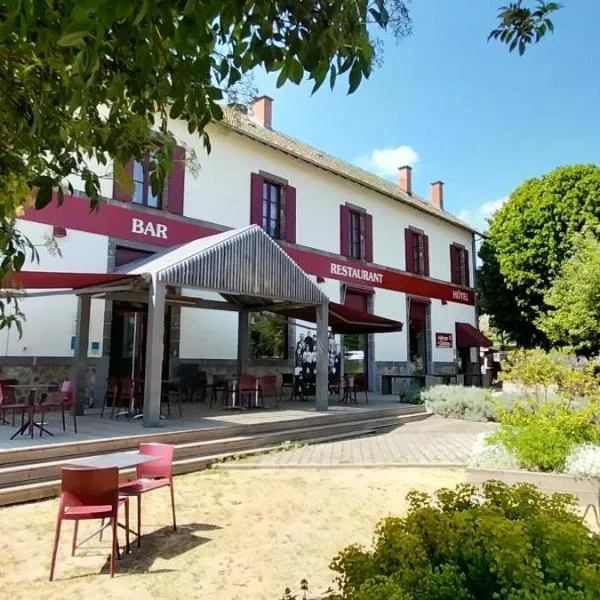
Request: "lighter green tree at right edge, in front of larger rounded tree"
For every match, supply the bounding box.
[538,231,600,355]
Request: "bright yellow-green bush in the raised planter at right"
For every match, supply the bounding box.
[487,400,600,472]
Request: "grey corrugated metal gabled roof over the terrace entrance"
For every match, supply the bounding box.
[119,225,328,305]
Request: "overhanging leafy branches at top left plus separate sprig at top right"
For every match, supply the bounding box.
[0,0,559,327]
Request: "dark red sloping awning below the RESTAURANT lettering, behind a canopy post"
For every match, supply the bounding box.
[277,302,402,334]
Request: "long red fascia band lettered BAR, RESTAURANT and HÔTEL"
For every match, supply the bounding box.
[23,196,475,306]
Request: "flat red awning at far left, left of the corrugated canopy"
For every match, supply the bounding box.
[2,271,132,290]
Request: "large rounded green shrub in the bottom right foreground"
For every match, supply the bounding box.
[330,481,600,600]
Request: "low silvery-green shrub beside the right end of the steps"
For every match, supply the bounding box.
[421,385,495,421]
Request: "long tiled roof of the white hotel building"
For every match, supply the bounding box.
[220,107,478,233]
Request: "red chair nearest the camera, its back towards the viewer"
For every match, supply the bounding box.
[50,467,129,581]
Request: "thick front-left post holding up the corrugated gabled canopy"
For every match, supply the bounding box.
[144,277,167,427]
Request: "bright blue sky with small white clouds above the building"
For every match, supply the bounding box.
[255,0,600,232]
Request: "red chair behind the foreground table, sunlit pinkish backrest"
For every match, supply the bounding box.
[119,443,177,548]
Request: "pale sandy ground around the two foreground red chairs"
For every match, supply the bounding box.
[0,468,464,600]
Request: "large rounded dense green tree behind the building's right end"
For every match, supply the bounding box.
[478,165,600,347]
